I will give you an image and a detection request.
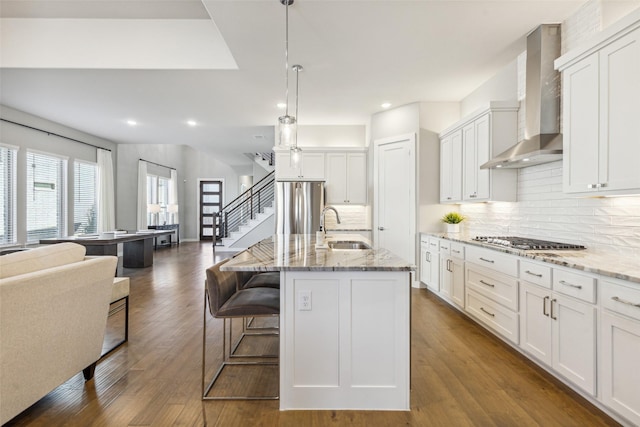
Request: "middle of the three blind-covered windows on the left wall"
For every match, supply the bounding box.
[27,151,67,242]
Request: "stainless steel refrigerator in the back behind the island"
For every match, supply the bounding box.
[275,181,324,234]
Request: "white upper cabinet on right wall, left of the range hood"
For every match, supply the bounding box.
[440,102,518,203]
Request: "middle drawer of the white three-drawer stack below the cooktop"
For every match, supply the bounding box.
[466,264,518,310]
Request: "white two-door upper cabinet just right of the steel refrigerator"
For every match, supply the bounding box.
[325,152,367,205]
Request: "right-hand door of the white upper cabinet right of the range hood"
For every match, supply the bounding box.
[598,30,640,191]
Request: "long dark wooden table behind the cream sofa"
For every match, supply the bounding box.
[40,230,174,268]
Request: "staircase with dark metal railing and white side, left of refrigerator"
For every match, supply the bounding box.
[216,172,275,251]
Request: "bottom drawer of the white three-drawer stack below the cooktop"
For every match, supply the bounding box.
[466,289,519,344]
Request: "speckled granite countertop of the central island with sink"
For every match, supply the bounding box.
[221,233,416,271]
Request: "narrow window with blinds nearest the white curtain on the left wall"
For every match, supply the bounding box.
[73,161,98,234]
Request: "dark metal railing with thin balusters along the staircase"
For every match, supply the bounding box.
[218,171,275,244]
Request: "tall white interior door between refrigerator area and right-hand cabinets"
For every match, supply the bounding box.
[374,134,416,263]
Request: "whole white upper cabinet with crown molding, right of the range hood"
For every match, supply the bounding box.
[556,16,640,194]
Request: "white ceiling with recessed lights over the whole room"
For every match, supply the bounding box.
[0,0,585,165]
